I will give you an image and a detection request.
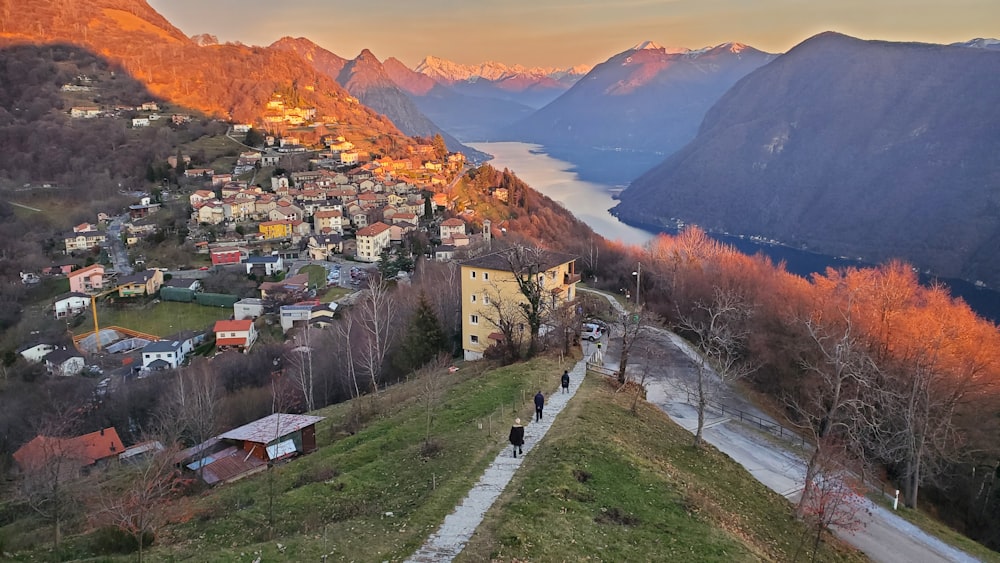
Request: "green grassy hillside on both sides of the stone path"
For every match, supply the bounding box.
[0,358,856,561]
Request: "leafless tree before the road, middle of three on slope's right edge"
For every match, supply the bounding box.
[678,286,754,448]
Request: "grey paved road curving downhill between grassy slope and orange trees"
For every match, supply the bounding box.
[584,290,978,563]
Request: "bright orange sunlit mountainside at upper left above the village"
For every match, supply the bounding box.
[0,0,413,150]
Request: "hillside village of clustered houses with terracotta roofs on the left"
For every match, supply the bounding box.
[7,95,512,484]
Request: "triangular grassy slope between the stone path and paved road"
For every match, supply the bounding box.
[458,377,863,561]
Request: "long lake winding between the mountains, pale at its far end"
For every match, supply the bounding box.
[466,142,1000,322]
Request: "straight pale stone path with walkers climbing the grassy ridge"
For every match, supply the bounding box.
[407,350,596,563]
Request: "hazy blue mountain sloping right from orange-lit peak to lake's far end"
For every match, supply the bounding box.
[382,58,534,141]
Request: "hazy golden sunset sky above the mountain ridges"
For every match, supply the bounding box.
[148,0,1000,68]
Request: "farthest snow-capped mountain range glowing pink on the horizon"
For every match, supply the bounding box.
[413,56,587,108]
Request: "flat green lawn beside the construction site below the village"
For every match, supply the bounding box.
[74,299,233,336]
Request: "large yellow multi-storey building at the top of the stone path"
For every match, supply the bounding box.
[461,250,580,360]
